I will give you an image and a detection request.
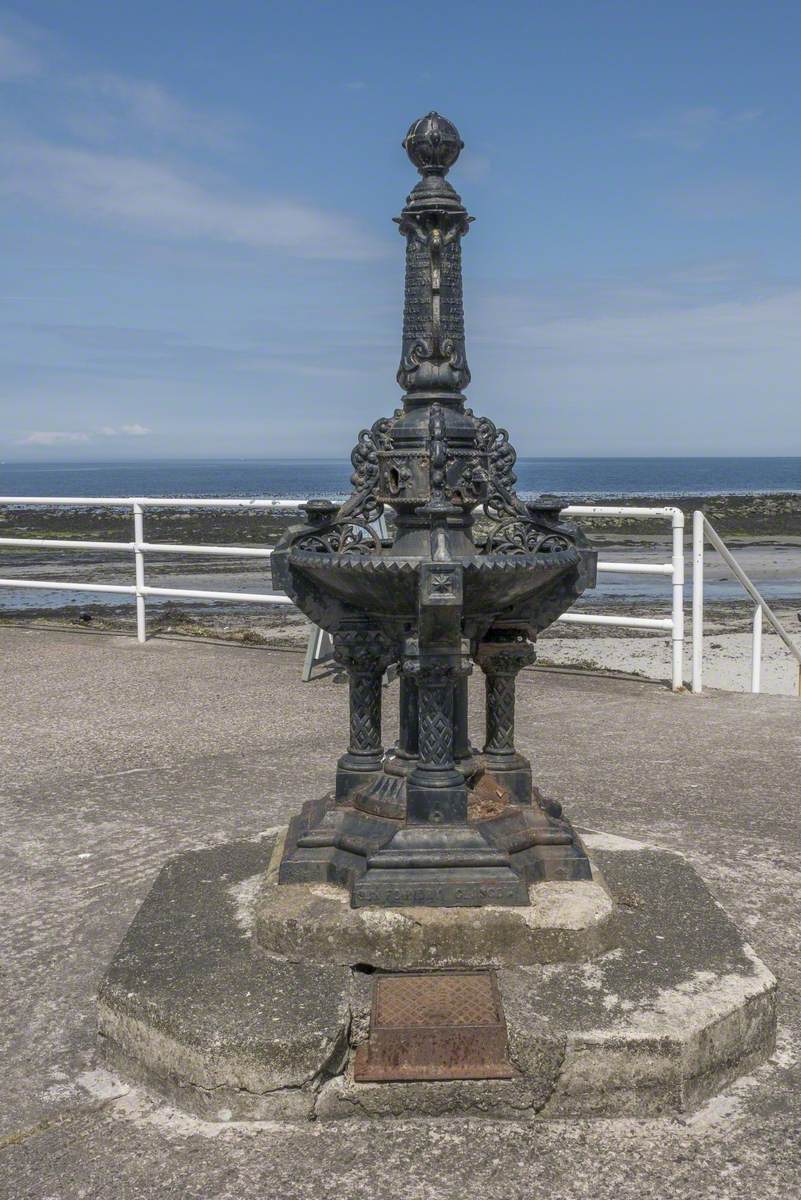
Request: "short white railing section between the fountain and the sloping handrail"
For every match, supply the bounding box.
[558,504,685,691]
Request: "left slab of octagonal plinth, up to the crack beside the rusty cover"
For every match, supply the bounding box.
[97,840,350,1120]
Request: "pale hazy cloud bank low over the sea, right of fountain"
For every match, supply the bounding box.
[471,280,801,455]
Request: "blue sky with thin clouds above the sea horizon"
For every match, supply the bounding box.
[0,0,801,461]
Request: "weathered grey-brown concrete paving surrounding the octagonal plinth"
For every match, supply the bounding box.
[0,629,801,1200]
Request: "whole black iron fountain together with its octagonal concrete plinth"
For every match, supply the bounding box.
[97,113,776,1122]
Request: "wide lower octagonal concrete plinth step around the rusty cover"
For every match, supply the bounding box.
[98,835,776,1121]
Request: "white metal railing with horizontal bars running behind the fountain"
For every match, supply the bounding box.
[0,496,685,691]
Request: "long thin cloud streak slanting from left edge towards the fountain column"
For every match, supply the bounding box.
[0,142,385,260]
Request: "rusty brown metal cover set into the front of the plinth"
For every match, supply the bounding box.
[354,971,517,1082]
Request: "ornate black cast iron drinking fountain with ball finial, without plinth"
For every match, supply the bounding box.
[272,113,597,907]
